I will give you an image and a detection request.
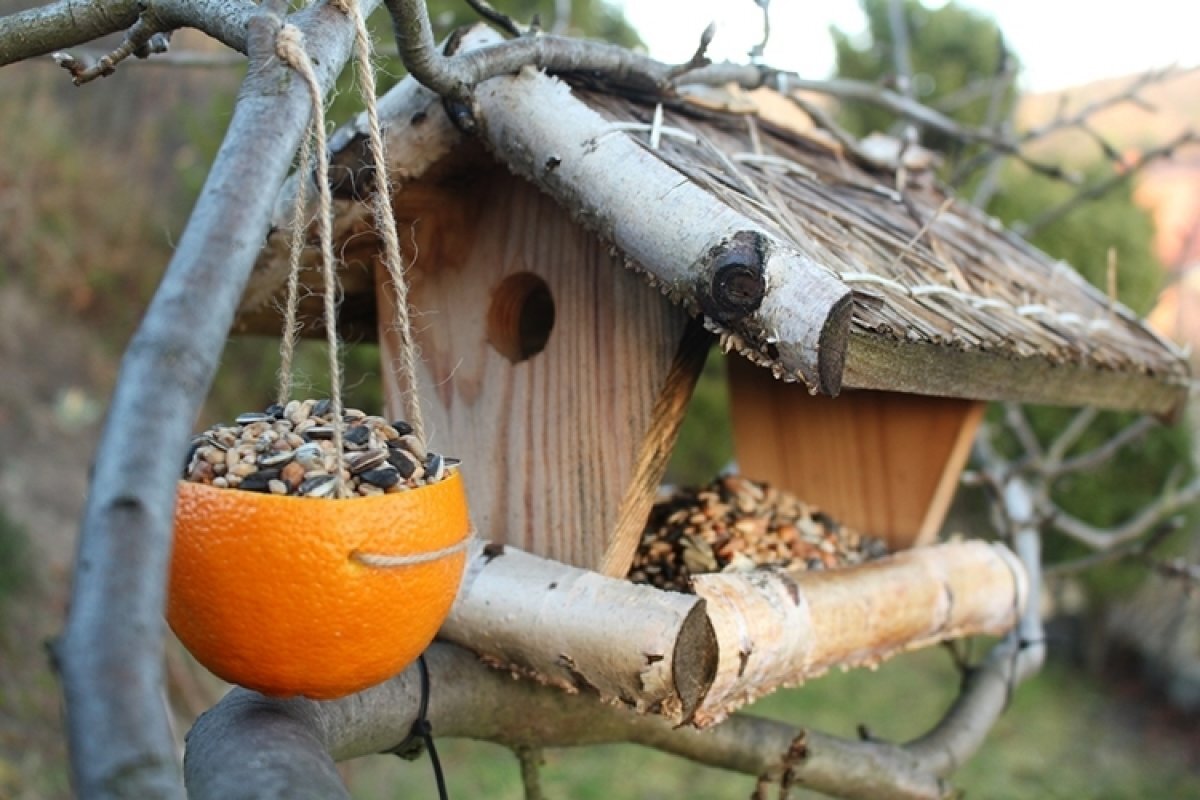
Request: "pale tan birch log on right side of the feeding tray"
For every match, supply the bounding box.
[694,541,1028,727]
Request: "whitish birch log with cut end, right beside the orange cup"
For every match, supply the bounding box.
[439,545,716,722]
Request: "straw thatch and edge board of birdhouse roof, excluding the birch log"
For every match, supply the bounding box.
[236,65,1190,415]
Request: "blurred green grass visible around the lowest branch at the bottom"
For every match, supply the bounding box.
[346,649,1200,800]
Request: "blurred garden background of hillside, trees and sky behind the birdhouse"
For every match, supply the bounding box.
[0,0,1200,800]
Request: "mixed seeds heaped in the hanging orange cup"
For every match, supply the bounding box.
[184,399,458,498]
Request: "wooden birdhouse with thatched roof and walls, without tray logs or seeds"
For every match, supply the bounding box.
[239,28,1188,576]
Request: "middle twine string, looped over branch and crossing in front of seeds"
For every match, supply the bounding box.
[275,24,346,498]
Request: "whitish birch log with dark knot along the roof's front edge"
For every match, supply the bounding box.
[474,68,852,395]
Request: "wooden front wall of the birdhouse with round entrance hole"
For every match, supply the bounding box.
[377,169,686,570]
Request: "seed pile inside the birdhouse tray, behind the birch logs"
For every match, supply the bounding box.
[629,476,887,593]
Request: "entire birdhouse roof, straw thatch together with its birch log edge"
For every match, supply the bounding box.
[244,49,1190,414]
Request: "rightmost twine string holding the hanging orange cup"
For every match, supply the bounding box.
[331,0,425,443]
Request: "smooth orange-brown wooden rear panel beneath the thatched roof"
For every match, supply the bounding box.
[730,359,982,549]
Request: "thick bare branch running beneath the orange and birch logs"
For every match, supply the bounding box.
[184,644,948,800]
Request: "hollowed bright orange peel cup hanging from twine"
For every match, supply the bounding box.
[167,471,470,699]
